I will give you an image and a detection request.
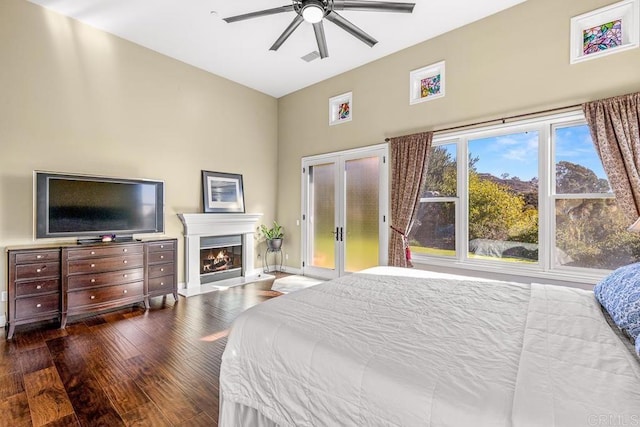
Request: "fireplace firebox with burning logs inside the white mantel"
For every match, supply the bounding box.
[200,234,242,283]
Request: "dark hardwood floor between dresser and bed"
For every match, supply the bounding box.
[0,273,284,427]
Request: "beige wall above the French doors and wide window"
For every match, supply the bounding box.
[277,0,640,268]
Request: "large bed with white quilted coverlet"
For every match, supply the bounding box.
[219,267,640,427]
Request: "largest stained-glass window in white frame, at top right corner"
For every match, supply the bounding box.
[570,0,640,64]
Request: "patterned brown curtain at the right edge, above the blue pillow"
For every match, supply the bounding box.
[582,93,640,224]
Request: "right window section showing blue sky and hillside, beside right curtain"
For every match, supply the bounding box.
[552,123,640,270]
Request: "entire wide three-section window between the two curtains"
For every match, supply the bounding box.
[409,112,640,281]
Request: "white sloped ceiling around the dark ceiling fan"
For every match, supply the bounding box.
[30,0,525,98]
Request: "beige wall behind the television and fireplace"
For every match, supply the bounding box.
[0,0,278,317]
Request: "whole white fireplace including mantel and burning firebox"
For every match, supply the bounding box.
[178,213,264,297]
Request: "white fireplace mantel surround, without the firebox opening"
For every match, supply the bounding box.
[178,213,264,297]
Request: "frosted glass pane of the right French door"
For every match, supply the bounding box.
[344,157,380,272]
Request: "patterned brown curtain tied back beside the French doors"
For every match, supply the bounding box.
[389,132,433,267]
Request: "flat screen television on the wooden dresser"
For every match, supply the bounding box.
[34,171,164,243]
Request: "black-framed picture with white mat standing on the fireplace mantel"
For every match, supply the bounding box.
[202,170,244,213]
